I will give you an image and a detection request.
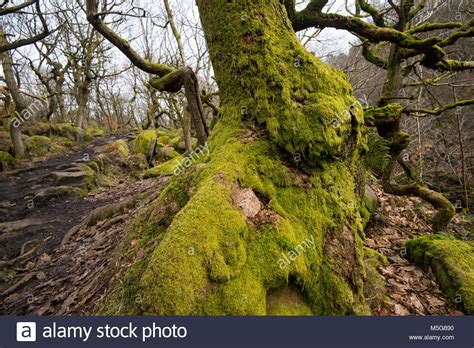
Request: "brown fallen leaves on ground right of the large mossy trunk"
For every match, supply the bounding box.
[365,187,463,316]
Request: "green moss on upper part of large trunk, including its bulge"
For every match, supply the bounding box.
[194,2,363,165]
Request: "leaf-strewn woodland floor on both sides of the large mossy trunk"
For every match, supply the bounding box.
[0,138,468,315]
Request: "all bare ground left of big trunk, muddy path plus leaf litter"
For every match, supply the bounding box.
[0,137,166,315]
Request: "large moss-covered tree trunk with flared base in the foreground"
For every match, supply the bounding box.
[107,0,367,315]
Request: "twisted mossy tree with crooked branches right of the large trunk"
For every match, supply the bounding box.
[288,0,474,230]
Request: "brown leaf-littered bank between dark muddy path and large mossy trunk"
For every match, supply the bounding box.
[0,174,167,315]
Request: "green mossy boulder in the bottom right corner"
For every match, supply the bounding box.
[406,235,474,315]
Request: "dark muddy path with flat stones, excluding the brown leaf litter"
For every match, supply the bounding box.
[0,137,116,260]
